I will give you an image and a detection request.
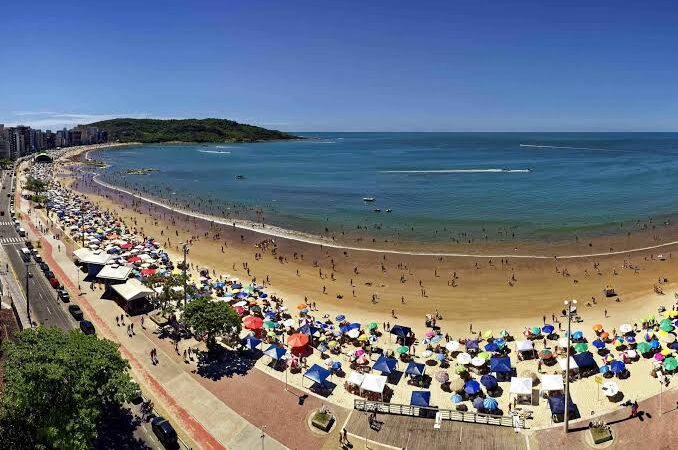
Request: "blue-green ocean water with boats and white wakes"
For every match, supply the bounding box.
[90,133,678,241]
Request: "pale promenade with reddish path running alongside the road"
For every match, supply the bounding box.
[23,204,285,449]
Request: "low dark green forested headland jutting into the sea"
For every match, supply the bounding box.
[89,119,300,143]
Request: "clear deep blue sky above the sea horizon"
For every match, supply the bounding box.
[0,0,678,131]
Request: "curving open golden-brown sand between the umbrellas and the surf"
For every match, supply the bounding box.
[50,146,678,337]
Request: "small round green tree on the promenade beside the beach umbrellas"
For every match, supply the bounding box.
[182,298,241,348]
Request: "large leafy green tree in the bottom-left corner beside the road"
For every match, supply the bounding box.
[0,327,135,450]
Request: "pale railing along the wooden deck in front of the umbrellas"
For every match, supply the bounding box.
[353,399,529,429]
